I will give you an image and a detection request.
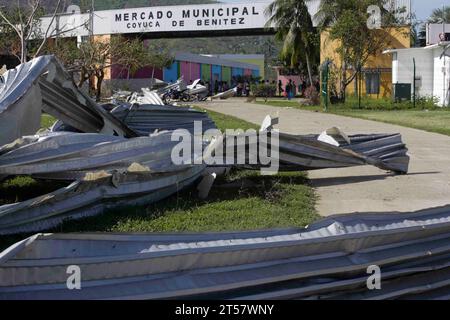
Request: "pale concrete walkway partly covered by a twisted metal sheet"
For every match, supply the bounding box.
[202,99,450,216]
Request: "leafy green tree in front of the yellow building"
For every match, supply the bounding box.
[315,0,404,101]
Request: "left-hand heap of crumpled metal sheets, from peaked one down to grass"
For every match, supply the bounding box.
[0,56,215,235]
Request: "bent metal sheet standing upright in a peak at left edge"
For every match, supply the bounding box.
[0,56,136,145]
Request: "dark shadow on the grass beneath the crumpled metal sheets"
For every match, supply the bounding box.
[0,171,315,252]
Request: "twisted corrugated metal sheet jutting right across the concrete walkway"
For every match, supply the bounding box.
[219,132,409,173]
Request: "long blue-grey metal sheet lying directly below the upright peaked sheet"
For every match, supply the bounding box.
[0,132,186,175]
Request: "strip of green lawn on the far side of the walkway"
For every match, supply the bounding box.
[257,100,450,135]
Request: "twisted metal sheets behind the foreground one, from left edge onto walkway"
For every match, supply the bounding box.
[0,56,409,252]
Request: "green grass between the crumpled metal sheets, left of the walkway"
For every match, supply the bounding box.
[0,112,319,250]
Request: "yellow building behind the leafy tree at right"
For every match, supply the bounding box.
[320,26,411,98]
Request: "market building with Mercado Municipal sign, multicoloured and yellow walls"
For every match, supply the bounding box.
[0,0,410,97]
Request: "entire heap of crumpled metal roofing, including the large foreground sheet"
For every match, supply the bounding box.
[0,56,428,299]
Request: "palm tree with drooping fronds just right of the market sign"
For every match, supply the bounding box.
[266,0,318,85]
